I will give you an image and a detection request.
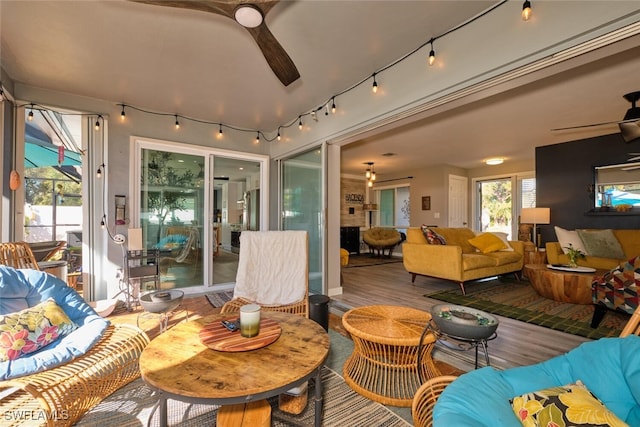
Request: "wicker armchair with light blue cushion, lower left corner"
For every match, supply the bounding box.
[0,266,149,427]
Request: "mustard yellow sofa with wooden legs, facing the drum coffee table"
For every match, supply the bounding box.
[402,227,524,295]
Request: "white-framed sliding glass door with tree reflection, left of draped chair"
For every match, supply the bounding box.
[131,139,268,289]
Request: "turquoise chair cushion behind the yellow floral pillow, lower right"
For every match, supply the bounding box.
[433,335,640,427]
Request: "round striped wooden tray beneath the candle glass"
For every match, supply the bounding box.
[199,318,282,352]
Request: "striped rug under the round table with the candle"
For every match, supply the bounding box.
[76,366,410,427]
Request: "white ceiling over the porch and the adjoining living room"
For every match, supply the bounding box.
[0,0,640,175]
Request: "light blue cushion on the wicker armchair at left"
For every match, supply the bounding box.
[0,265,109,380]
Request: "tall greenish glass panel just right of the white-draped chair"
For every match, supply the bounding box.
[281,149,323,294]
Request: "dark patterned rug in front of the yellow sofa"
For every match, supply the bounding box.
[425,279,629,339]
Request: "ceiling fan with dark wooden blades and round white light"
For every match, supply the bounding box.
[129,0,300,86]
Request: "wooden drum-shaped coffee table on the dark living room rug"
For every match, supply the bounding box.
[524,264,605,305]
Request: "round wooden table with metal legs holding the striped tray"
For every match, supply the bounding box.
[140,312,329,427]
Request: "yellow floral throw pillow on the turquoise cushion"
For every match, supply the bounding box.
[510,380,628,427]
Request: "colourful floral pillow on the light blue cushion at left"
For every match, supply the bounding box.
[0,298,78,362]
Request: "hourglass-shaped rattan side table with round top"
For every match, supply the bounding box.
[342,305,440,407]
